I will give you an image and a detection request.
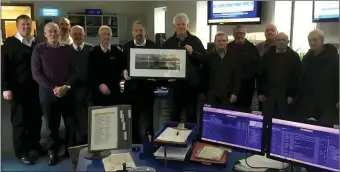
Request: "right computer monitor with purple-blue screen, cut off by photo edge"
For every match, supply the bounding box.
[268,119,339,171]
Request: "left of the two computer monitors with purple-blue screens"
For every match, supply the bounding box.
[200,106,264,154]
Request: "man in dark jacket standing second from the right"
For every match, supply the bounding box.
[258,33,301,119]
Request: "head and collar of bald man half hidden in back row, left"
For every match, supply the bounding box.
[59,17,73,45]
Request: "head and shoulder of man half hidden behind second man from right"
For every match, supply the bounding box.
[256,24,277,57]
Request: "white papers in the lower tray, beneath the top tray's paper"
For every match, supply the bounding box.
[153,145,191,161]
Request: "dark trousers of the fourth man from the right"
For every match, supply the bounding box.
[235,79,255,110]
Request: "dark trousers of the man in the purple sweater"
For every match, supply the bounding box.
[41,93,76,154]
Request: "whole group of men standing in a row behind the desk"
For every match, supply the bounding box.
[2,13,339,165]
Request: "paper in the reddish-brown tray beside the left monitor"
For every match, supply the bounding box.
[196,146,225,161]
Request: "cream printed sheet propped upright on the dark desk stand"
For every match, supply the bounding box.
[89,107,118,150]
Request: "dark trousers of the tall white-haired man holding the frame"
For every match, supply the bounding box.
[169,85,199,124]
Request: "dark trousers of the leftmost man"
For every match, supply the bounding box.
[10,87,42,156]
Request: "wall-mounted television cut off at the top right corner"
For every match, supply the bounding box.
[313,1,339,22]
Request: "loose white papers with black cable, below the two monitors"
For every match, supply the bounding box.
[235,155,288,172]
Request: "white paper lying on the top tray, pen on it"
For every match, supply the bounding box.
[156,127,191,143]
